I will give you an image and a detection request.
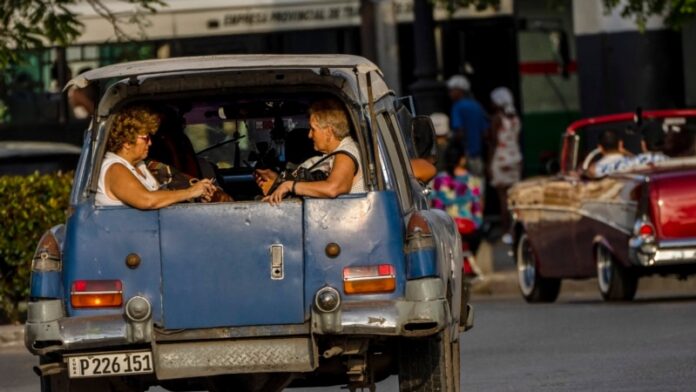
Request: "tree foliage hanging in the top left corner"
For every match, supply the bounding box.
[0,0,165,69]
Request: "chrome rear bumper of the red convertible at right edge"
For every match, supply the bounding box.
[628,237,696,267]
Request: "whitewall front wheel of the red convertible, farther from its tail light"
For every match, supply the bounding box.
[515,232,561,303]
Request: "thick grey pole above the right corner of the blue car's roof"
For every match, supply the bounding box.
[360,0,401,95]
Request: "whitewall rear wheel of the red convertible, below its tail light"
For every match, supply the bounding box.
[595,245,638,301]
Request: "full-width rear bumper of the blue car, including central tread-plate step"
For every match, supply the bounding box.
[25,278,457,380]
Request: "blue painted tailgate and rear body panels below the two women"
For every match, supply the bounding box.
[59,191,414,329]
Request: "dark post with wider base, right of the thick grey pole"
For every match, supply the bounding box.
[409,0,447,114]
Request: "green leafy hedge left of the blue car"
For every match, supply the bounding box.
[0,173,73,322]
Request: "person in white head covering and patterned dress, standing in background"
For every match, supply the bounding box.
[488,87,522,244]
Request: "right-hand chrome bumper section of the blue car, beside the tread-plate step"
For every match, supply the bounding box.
[312,278,450,336]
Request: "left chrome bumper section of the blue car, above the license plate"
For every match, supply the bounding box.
[24,299,152,355]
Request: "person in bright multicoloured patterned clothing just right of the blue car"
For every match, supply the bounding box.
[431,143,483,253]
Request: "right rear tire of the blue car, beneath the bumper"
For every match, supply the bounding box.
[399,327,461,392]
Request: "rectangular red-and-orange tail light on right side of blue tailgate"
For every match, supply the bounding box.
[343,264,396,294]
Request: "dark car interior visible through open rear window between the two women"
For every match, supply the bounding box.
[100,93,364,201]
